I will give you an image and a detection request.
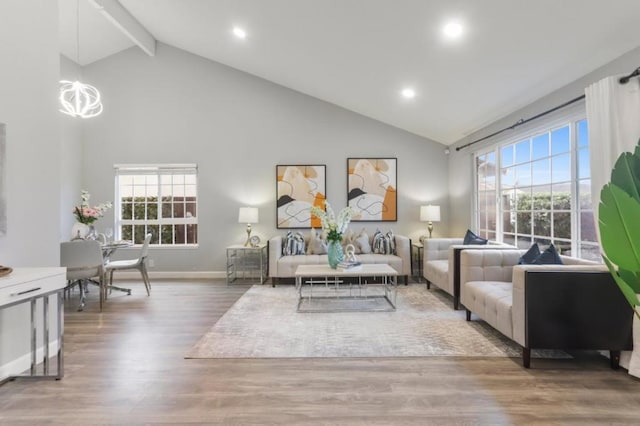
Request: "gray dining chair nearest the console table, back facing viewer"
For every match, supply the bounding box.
[60,240,106,312]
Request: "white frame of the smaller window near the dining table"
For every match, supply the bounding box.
[114,164,199,247]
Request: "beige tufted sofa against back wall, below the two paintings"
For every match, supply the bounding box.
[269,234,411,287]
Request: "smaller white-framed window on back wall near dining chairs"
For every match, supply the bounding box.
[115,164,198,246]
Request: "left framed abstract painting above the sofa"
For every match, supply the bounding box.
[276,165,327,229]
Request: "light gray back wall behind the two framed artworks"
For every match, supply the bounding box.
[83,43,448,272]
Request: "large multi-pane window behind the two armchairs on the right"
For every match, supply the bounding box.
[475,114,600,259]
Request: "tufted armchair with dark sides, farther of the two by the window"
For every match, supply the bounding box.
[422,238,515,309]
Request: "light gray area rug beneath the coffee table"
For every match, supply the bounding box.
[186,284,566,358]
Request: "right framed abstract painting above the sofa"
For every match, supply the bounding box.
[347,158,398,222]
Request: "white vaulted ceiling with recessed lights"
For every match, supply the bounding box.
[58,0,640,144]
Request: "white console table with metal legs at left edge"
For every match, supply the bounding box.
[0,268,67,384]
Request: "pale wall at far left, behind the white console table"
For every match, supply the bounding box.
[0,0,60,373]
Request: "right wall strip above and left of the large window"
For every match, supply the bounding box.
[449,48,640,240]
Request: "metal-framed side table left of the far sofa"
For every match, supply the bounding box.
[227,244,269,285]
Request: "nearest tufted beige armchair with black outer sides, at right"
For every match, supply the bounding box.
[460,249,633,368]
